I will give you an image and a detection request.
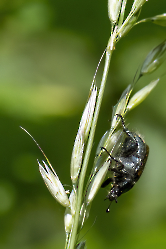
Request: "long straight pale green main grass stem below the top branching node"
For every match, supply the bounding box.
[67,50,113,249]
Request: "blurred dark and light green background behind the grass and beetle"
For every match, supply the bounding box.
[0,0,166,249]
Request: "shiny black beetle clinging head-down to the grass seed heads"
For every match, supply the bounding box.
[101,114,149,212]
